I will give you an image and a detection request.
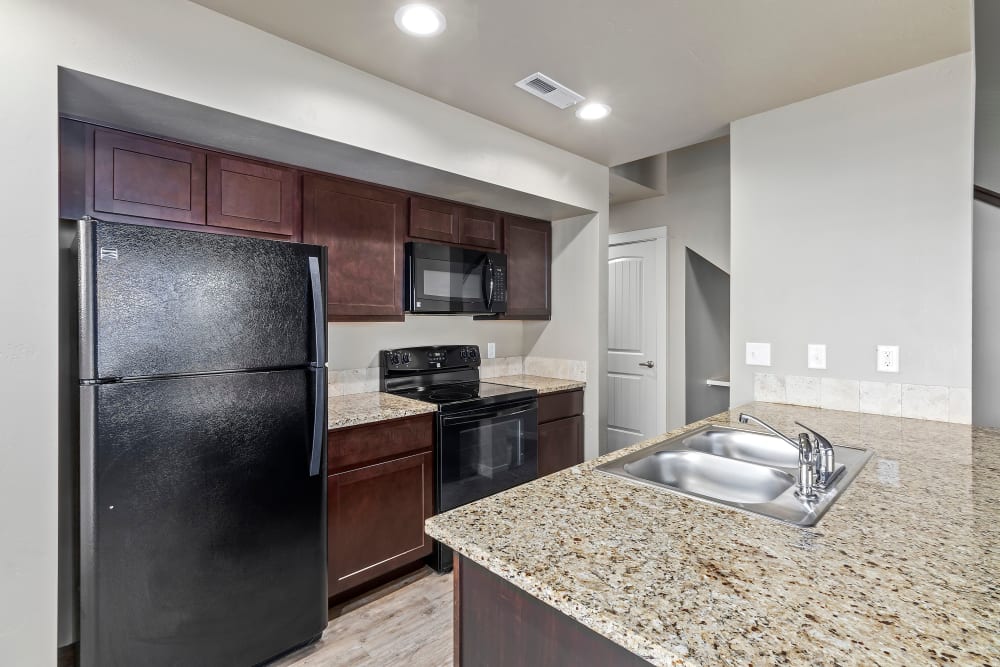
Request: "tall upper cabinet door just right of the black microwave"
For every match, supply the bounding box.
[504,216,552,320]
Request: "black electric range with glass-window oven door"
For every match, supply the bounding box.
[379,345,538,572]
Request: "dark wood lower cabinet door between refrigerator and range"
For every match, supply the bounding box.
[327,451,434,595]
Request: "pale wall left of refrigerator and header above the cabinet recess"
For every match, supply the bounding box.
[0,0,608,665]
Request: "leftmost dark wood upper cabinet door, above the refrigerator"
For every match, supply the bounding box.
[94,129,206,225]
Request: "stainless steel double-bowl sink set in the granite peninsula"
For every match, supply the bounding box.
[596,426,872,526]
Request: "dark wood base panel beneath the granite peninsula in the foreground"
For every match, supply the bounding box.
[454,555,649,667]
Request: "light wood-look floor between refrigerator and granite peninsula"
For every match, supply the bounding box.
[271,568,453,667]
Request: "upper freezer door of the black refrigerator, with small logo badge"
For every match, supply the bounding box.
[80,221,326,380]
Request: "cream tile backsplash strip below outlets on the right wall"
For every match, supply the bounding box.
[753,373,972,424]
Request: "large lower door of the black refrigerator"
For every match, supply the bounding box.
[80,369,327,667]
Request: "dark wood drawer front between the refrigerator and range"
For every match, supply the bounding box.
[327,414,434,472]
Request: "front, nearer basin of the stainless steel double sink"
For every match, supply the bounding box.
[624,451,795,503]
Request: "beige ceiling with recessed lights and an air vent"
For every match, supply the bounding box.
[189,0,971,165]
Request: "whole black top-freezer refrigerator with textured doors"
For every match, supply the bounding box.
[74,219,327,667]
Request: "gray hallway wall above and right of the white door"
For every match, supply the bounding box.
[608,137,729,428]
